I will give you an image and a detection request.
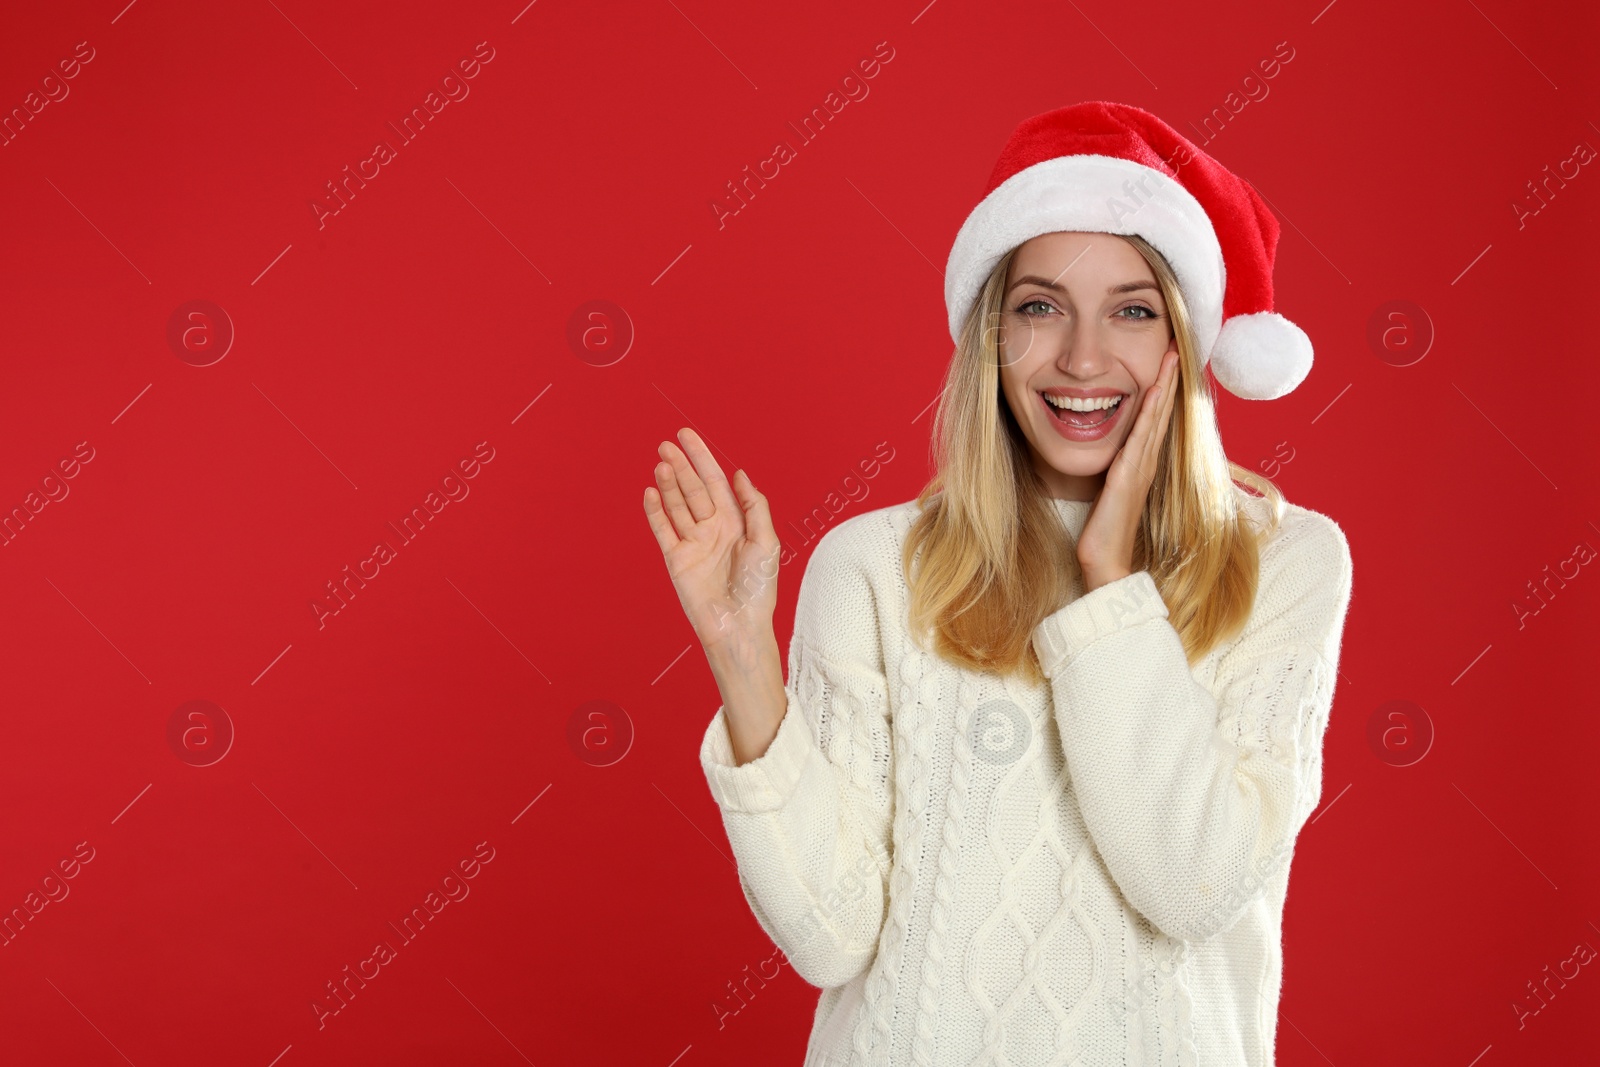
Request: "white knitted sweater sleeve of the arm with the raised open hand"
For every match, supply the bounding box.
[699,517,893,989]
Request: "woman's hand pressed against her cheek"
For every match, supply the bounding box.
[1078,352,1178,593]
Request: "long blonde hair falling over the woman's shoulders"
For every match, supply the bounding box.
[901,235,1283,683]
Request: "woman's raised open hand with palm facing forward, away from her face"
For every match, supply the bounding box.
[645,427,779,653]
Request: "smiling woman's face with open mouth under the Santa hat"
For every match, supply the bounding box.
[998,232,1178,501]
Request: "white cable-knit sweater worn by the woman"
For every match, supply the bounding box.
[699,490,1350,1067]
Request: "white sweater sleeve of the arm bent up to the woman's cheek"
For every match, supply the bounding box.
[1034,510,1350,941]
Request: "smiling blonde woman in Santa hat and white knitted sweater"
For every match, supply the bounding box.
[645,101,1350,1067]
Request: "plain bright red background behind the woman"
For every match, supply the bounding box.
[0,0,1600,1067]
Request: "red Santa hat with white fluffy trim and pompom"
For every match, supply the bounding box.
[944,101,1312,400]
